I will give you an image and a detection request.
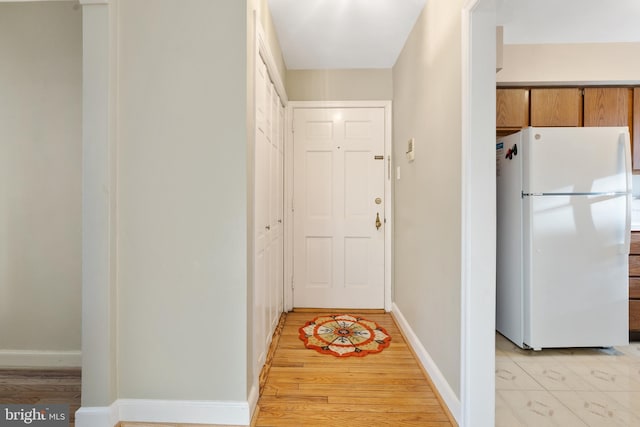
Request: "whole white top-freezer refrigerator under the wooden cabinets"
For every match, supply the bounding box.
[496,127,631,350]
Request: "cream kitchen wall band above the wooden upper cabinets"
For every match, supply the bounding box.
[496,43,640,85]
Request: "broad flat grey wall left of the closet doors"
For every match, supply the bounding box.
[117,0,248,401]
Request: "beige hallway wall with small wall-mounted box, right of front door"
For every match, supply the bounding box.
[393,0,462,398]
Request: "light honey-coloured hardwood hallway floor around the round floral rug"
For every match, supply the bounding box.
[252,312,455,427]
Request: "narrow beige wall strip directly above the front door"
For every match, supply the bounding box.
[287,69,393,101]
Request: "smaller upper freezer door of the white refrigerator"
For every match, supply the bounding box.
[523,127,631,193]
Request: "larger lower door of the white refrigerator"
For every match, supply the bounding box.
[524,195,629,349]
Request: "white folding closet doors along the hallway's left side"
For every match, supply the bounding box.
[253,56,284,367]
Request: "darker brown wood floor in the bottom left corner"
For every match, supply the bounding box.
[0,368,81,427]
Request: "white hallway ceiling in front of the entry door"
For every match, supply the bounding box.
[268,0,426,70]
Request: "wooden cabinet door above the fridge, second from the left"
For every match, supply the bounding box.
[531,88,582,126]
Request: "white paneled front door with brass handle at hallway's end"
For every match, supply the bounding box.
[293,108,385,308]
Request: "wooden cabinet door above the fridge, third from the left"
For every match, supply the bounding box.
[584,87,633,127]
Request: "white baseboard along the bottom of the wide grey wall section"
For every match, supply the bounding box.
[76,400,251,427]
